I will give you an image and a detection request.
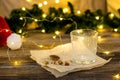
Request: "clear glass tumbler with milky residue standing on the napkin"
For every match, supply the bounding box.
[70,29,98,64]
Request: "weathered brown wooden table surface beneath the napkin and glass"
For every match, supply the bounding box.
[0,33,120,80]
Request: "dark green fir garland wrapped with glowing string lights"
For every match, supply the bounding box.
[5,0,120,35]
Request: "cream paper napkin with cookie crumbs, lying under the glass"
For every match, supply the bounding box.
[30,43,110,77]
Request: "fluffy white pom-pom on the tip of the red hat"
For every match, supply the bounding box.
[7,33,22,50]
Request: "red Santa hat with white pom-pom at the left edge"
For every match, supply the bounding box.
[0,16,22,50]
